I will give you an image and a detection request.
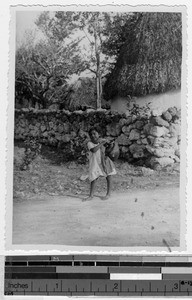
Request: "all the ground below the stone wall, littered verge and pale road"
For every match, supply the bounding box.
[13,145,180,247]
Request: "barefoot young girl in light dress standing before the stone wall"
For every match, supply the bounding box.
[84,128,116,201]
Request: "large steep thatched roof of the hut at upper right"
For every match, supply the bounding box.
[104,12,182,99]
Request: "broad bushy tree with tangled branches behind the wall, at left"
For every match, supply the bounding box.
[15,17,85,108]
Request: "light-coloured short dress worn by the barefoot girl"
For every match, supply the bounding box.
[87,142,117,181]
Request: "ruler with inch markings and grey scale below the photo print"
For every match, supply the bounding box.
[4,255,192,297]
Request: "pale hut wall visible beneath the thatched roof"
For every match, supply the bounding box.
[111,89,181,113]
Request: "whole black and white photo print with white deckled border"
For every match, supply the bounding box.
[11,6,186,252]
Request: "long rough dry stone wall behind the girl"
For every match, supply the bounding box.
[15,107,181,169]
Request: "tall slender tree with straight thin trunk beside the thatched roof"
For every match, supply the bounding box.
[36,11,132,108]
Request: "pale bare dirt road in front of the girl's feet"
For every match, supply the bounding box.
[13,185,180,247]
